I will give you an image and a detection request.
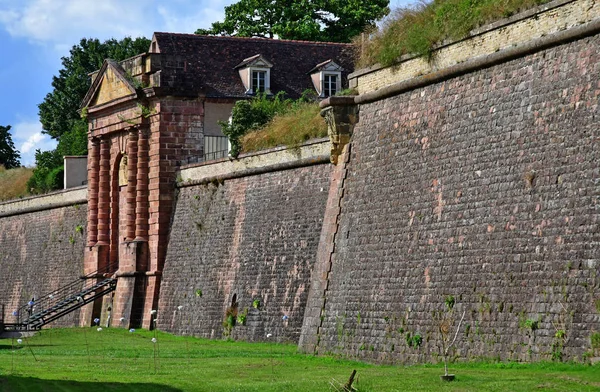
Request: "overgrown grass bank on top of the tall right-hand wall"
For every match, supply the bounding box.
[354,0,550,68]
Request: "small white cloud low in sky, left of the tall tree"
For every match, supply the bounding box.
[10,121,56,166]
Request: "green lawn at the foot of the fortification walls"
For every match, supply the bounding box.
[0,328,600,392]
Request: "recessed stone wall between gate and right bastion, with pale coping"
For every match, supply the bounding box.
[158,142,331,341]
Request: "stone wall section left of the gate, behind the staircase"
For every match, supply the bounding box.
[0,188,87,326]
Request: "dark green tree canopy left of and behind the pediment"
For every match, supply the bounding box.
[38,37,150,139]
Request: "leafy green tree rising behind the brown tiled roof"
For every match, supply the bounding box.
[196,0,389,42]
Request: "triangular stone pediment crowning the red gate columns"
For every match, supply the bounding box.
[81,60,136,108]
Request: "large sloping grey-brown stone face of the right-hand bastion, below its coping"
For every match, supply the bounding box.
[301,6,600,362]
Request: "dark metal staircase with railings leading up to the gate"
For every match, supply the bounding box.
[0,264,117,333]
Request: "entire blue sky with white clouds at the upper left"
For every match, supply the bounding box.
[0,0,413,166]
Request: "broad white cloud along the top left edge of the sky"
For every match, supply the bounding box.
[0,0,235,51]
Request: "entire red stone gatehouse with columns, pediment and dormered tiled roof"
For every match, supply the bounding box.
[82,33,353,327]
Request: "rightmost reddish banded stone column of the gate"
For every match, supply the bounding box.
[135,128,149,241]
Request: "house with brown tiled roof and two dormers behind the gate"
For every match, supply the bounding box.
[83,32,353,160]
